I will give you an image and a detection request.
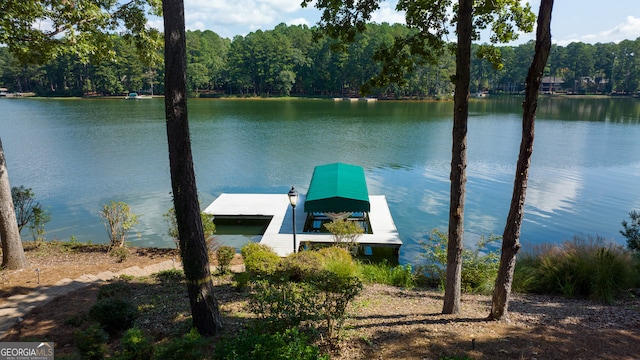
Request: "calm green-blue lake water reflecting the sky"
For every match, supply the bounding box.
[0,97,640,262]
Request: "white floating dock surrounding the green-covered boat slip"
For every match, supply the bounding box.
[204,193,402,257]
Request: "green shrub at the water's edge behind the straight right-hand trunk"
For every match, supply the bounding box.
[419,229,500,294]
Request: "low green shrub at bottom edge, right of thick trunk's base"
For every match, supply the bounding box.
[214,329,329,360]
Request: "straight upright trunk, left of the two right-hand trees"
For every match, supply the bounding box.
[442,0,473,314]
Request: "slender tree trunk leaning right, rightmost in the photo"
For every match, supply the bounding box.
[489,0,553,320]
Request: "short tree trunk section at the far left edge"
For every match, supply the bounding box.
[0,136,28,270]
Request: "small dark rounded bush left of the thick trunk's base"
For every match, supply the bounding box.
[89,298,138,334]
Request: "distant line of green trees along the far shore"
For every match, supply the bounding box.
[0,23,640,98]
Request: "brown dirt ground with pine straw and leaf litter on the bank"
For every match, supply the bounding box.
[0,243,640,360]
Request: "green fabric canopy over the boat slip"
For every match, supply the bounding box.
[304,163,371,213]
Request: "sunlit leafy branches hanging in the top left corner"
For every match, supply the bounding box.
[0,0,161,65]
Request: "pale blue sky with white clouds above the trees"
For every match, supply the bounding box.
[151,0,640,46]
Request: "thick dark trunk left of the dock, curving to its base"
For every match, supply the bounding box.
[162,0,222,336]
